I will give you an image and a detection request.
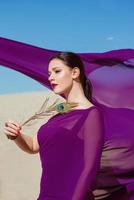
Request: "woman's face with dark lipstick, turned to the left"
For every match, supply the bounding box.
[48,58,73,94]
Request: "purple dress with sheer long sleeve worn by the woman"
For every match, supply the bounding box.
[37,106,104,200]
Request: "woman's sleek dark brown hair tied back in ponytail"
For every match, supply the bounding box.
[49,52,92,100]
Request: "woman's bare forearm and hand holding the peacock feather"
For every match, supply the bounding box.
[4,120,39,154]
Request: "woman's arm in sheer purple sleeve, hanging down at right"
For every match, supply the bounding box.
[72,108,104,200]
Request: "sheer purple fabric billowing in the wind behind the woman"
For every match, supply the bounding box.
[0,38,134,200]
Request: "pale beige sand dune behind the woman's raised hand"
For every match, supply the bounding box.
[0,92,63,200]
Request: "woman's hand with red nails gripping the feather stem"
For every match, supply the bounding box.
[4,120,21,140]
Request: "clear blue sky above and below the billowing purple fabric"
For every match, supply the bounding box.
[0,0,134,95]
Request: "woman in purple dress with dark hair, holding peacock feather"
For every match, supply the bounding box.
[5,52,104,200]
